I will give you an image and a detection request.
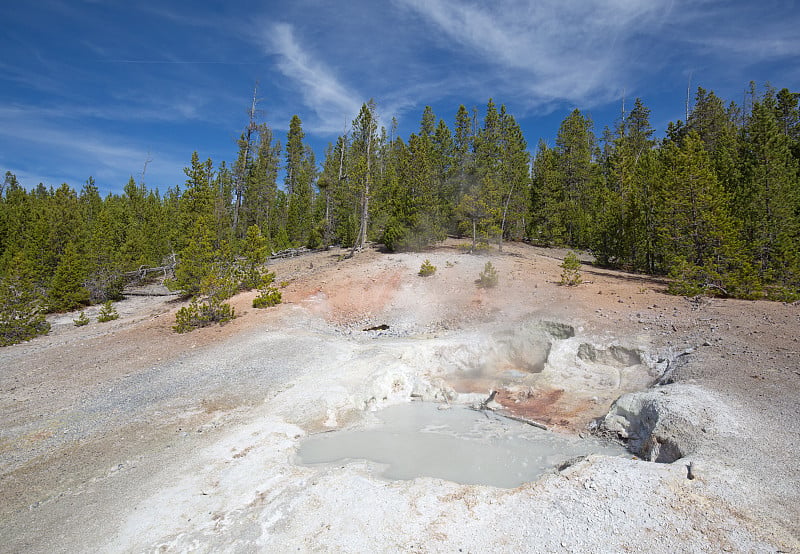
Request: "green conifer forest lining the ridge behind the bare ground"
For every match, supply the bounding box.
[0,85,800,344]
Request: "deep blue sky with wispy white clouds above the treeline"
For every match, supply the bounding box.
[0,0,800,193]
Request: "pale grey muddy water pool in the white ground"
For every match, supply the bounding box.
[296,402,626,488]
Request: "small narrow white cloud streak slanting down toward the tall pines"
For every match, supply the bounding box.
[263,23,367,133]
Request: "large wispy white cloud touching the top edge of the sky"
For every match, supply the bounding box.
[396,0,666,105]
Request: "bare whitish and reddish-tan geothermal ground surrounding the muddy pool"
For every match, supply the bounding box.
[0,241,800,552]
